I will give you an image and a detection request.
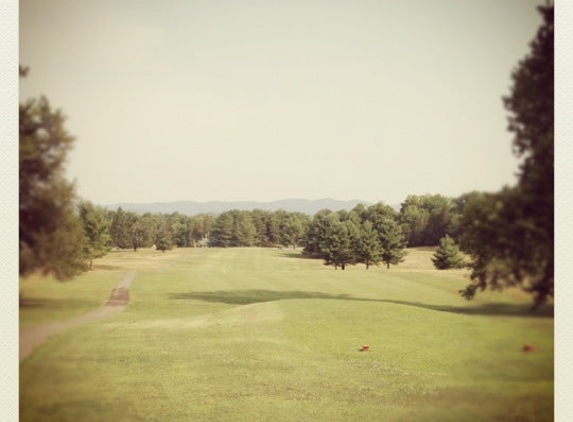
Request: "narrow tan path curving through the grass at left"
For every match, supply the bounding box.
[20,272,135,362]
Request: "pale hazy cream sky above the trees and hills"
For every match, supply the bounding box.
[20,0,541,204]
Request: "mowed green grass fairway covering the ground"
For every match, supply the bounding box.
[20,248,554,422]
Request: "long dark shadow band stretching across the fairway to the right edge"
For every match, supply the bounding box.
[169,289,554,318]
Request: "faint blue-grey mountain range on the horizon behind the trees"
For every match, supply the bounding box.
[106,198,399,215]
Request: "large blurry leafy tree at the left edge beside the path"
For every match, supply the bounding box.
[19,67,86,280]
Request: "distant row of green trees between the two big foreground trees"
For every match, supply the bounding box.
[21,189,478,279]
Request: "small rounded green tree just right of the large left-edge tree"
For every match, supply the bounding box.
[78,201,111,269]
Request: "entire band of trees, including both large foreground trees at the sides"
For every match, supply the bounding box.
[19,3,554,306]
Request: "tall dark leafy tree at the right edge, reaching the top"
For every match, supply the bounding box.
[460,4,554,307]
